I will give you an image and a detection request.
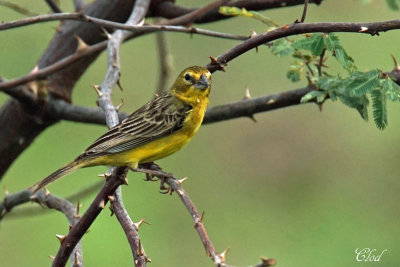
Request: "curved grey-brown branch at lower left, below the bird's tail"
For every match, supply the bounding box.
[0,189,83,267]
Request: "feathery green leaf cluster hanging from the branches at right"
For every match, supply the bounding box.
[271,33,400,130]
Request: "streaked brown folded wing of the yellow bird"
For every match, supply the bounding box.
[78,94,191,158]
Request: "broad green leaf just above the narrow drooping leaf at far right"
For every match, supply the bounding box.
[347,70,380,96]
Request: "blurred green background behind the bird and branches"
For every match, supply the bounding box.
[0,0,400,266]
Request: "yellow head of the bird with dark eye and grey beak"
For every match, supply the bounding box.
[171,66,211,105]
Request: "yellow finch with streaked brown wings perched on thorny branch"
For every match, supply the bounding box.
[31,66,211,192]
